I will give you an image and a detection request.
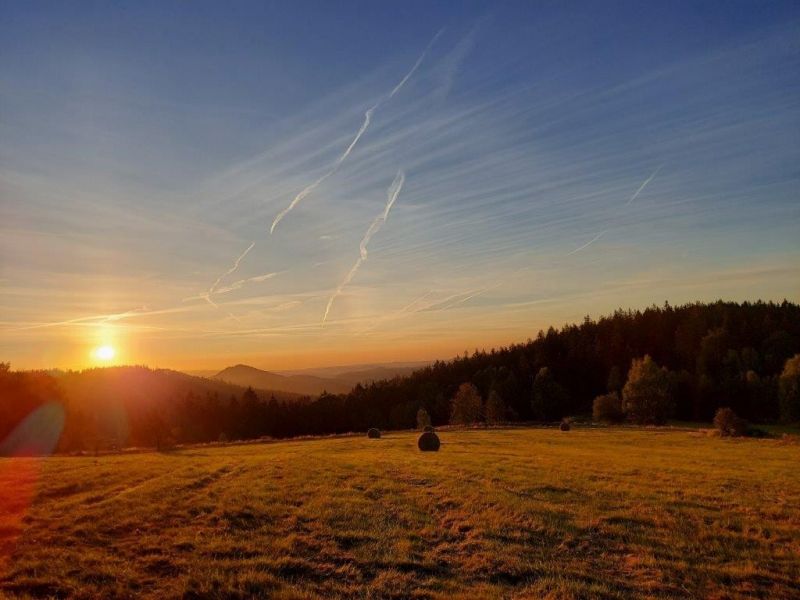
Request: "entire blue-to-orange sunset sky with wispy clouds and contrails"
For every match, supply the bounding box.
[0,1,800,370]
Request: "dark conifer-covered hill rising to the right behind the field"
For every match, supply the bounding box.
[275,301,800,435]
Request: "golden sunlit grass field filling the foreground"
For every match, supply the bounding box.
[0,429,800,599]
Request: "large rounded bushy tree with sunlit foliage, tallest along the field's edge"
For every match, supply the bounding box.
[622,354,673,425]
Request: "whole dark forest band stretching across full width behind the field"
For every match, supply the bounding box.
[0,301,800,451]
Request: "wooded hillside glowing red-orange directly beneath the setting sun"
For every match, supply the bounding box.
[0,362,304,455]
